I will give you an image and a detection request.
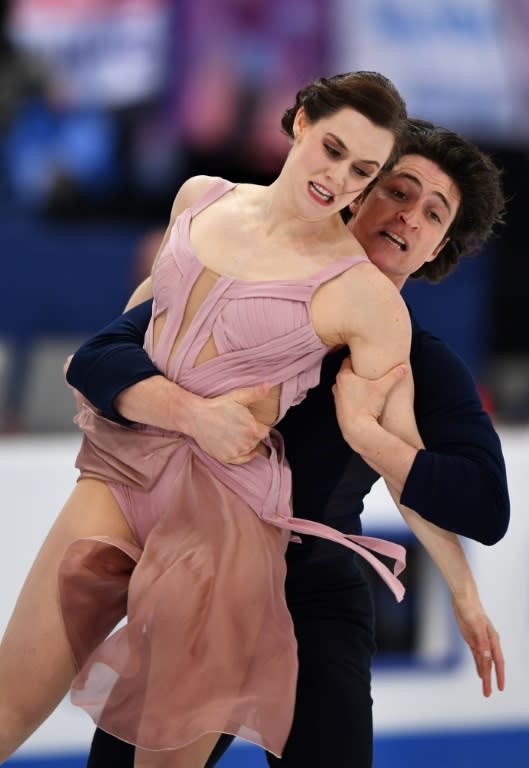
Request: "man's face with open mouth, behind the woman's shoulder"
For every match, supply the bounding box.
[348,155,461,290]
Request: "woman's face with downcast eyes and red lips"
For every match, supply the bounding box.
[289,107,395,218]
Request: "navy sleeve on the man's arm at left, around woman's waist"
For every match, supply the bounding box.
[66,300,160,423]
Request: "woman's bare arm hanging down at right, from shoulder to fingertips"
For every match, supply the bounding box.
[314,265,504,695]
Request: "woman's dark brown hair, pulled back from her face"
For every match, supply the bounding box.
[281,71,406,169]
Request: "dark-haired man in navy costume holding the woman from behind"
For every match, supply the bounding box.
[68,121,509,768]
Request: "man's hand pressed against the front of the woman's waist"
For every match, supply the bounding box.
[173,384,270,464]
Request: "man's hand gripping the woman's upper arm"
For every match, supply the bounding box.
[332,358,408,450]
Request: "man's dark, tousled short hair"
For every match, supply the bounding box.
[400,119,505,283]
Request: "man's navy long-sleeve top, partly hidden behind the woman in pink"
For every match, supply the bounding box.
[67,301,509,558]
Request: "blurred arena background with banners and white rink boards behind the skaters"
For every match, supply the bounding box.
[0,0,529,768]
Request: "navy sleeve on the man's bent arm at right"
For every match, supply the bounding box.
[400,333,510,544]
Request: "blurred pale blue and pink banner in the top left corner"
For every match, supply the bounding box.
[10,0,170,106]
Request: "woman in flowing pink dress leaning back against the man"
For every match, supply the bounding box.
[0,72,484,768]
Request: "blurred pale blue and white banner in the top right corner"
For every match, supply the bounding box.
[335,0,529,142]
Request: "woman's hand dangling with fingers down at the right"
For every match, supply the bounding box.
[452,597,505,696]
